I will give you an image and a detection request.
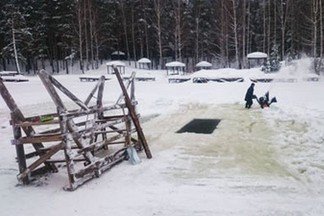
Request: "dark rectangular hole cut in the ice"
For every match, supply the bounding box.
[177,119,221,134]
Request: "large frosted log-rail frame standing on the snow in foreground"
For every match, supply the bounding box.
[0,68,152,190]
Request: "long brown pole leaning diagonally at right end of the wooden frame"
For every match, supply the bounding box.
[114,67,152,158]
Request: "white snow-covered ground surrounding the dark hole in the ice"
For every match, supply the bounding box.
[0,58,324,216]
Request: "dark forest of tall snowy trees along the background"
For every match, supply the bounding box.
[0,0,324,73]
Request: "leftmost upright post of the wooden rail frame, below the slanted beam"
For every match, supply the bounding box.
[11,112,29,184]
